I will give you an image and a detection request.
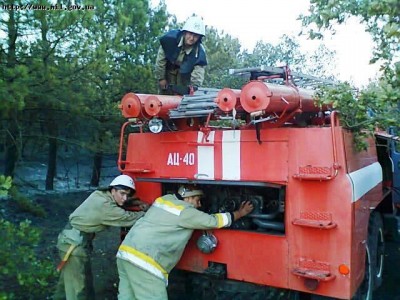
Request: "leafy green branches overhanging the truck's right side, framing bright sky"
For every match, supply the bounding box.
[300,0,400,148]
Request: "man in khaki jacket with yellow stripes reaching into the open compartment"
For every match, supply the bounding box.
[117,186,253,300]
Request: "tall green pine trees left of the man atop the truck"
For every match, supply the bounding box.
[0,0,170,180]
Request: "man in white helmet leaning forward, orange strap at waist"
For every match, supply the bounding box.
[53,175,148,300]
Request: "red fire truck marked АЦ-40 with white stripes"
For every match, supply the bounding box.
[118,66,400,299]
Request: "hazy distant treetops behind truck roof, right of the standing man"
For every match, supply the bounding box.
[203,31,336,89]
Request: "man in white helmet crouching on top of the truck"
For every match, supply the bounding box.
[155,16,207,94]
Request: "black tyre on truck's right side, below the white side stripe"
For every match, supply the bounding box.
[368,212,385,290]
